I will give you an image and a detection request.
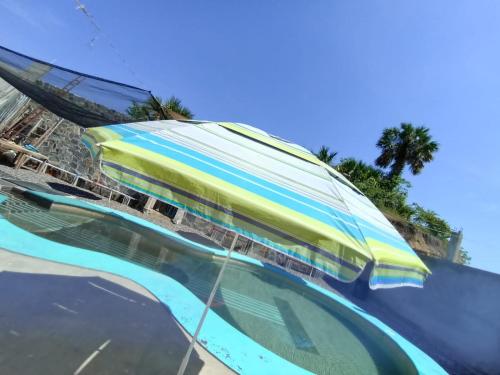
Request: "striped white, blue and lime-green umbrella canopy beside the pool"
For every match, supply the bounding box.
[82,121,430,289]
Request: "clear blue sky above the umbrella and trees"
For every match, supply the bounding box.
[0,0,500,273]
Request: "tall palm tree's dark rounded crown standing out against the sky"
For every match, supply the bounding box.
[375,123,439,178]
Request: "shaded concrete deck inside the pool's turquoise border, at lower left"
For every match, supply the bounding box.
[0,249,234,375]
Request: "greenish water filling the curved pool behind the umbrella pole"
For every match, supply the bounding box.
[0,193,416,374]
